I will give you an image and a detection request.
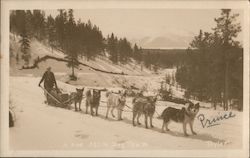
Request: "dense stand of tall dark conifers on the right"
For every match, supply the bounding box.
[176,9,243,110]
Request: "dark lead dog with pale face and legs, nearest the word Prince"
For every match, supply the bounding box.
[160,103,200,136]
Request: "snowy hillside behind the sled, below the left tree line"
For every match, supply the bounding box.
[10,34,171,88]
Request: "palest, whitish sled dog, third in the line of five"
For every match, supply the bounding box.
[106,91,126,120]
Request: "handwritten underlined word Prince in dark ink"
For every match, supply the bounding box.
[197,111,236,128]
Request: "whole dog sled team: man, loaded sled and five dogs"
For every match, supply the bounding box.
[39,67,200,136]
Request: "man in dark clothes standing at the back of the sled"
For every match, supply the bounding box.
[38,67,58,104]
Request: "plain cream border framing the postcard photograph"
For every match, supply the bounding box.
[0,0,250,158]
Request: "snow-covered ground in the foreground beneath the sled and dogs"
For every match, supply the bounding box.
[10,76,243,150]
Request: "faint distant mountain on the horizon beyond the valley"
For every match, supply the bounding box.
[131,35,193,49]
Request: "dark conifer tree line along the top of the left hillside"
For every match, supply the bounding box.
[10,9,142,78]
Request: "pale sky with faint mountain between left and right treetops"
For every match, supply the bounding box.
[46,9,243,48]
